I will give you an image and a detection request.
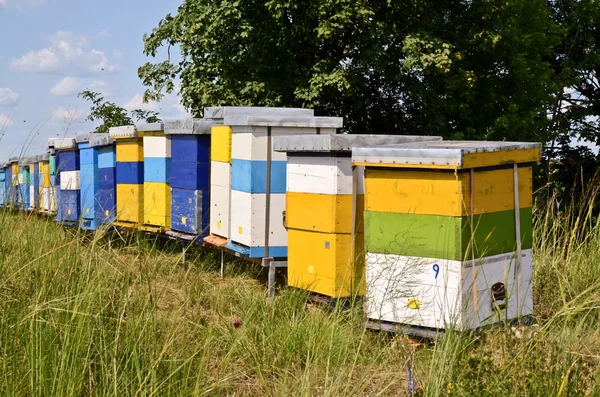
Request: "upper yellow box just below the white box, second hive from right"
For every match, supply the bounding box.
[285,192,364,234]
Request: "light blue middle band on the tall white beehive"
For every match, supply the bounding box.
[231,159,287,193]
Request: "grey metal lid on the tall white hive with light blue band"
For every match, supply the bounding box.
[223,116,344,128]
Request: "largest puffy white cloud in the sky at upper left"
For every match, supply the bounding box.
[10,30,120,76]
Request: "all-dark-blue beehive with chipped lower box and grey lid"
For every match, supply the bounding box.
[165,118,214,240]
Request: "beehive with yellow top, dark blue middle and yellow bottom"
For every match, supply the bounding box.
[109,125,144,229]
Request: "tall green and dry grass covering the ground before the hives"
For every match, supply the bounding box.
[0,193,600,396]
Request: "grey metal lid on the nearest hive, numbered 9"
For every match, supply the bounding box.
[352,141,541,168]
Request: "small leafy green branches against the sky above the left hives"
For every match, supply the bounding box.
[77,90,160,133]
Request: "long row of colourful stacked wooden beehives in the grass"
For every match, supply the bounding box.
[0,108,539,328]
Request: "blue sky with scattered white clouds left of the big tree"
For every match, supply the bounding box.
[0,0,186,162]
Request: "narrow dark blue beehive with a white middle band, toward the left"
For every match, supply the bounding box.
[54,138,81,226]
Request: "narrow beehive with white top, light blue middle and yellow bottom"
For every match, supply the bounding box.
[136,123,171,232]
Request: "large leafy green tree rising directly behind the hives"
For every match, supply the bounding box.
[138,0,558,140]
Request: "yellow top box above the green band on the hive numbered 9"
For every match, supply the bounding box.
[365,167,532,216]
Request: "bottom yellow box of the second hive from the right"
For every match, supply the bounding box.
[288,229,365,297]
